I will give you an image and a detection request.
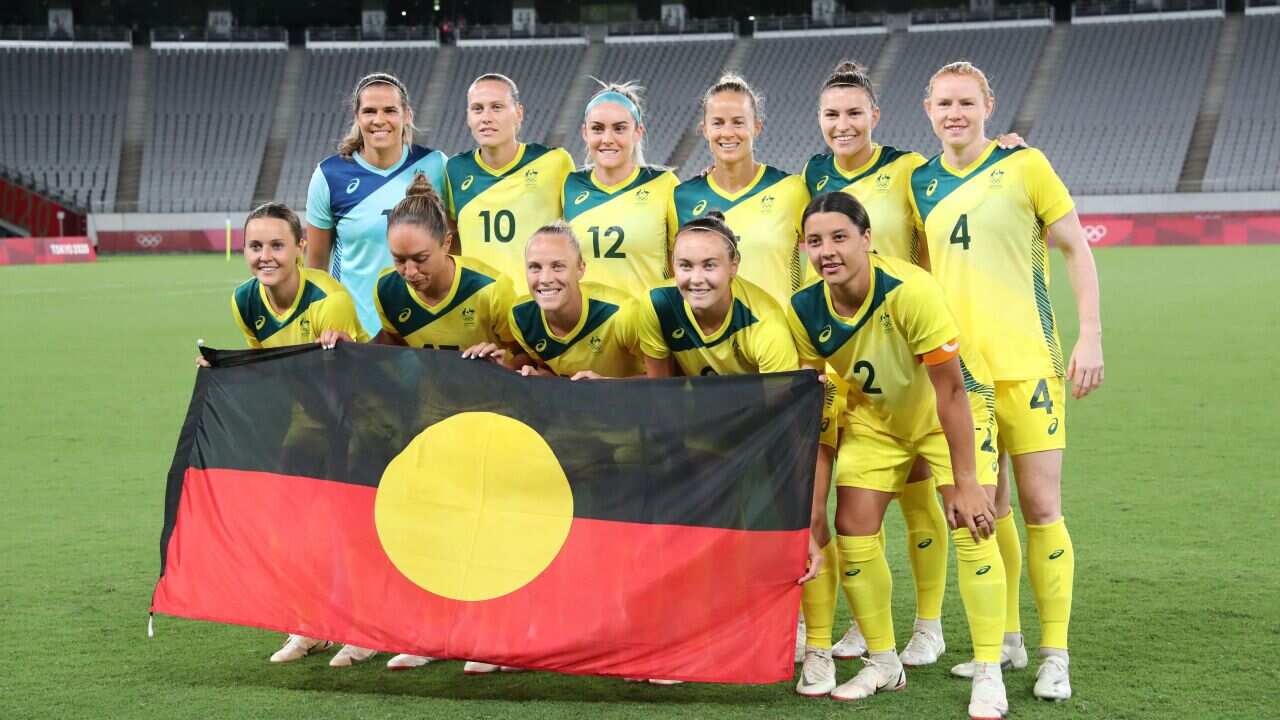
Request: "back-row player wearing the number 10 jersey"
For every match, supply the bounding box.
[445,73,573,283]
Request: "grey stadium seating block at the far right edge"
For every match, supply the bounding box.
[1204,15,1280,191]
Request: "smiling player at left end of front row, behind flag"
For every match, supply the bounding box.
[216,202,369,665]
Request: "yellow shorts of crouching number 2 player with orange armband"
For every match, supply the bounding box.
[835,415,998,495]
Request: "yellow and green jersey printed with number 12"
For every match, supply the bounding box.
[563,168,680,297]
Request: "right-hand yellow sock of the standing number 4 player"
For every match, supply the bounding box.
[1027,518,1075,650]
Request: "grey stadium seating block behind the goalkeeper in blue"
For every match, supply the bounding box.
[275,47,436,211]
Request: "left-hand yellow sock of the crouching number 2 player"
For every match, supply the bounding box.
[836,529,897,652]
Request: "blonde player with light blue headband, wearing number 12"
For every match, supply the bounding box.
[563,83,680,297]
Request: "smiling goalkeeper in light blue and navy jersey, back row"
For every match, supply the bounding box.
[306,73,445,334]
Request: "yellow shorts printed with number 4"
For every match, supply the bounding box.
[996,377,1066,455]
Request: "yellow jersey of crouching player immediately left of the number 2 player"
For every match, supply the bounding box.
[636,278,800,377]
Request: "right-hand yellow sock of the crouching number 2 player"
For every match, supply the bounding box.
[951,528,1005,662]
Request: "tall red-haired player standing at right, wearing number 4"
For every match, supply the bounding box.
[911,63,1102,701]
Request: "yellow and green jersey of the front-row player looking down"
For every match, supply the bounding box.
[374,258,515,350]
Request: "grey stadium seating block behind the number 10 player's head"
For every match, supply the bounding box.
[430,45,586,155]
